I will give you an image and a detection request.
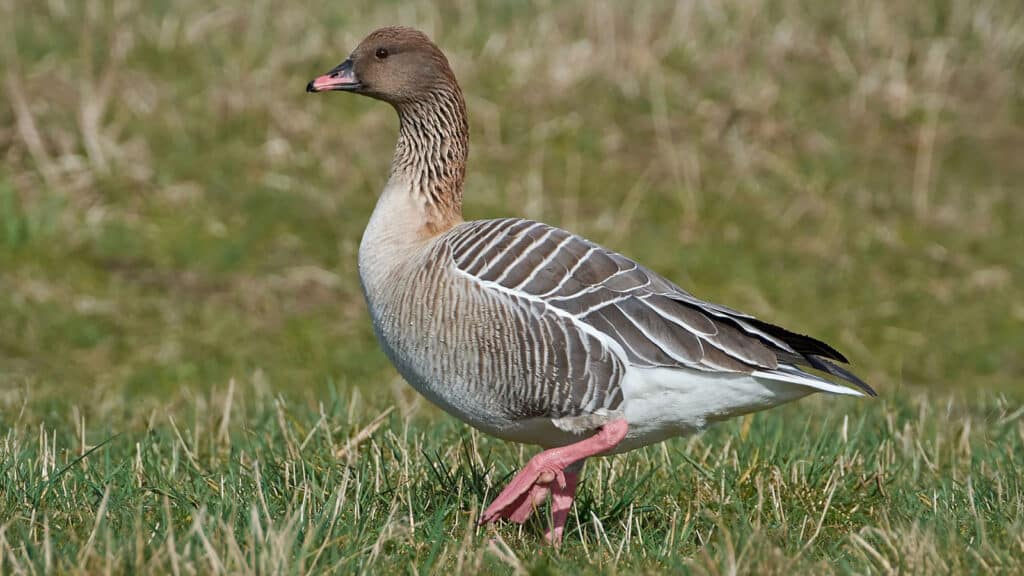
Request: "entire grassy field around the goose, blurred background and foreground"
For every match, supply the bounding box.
[0,0,1024,574]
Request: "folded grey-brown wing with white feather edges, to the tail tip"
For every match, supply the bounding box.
[446,218,874,396]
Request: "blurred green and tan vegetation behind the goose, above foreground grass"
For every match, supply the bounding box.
[0,0,1024,404]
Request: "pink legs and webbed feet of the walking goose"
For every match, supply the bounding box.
[480,419,629,545]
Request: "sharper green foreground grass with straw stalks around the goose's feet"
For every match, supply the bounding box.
[0,380,1024,574]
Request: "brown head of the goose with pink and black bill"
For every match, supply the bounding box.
[306,27,457,108]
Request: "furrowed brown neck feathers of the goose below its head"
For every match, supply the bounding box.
[391,82,469,236]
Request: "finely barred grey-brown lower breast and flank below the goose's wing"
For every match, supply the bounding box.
[367,260,624,447]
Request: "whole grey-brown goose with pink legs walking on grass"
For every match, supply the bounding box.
[306,27,876,545]
